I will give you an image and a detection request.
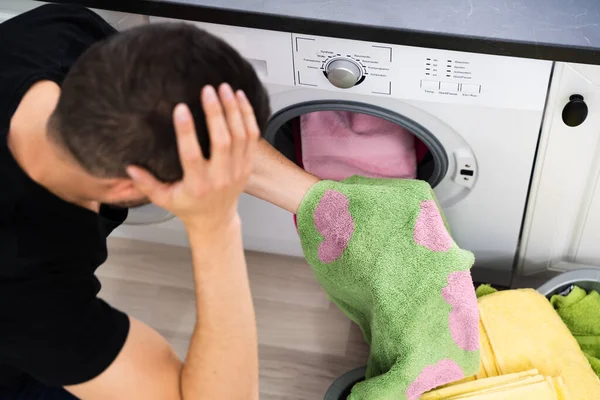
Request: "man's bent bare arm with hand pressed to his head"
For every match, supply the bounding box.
[66,85,259,400]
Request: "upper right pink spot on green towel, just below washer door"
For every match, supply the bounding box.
[414,200,453,252]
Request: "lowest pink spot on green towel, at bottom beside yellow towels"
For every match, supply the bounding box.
[406,359,464,400]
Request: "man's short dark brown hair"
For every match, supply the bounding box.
[48,23,270,182]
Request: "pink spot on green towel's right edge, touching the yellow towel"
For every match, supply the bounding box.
[442,271,479,351]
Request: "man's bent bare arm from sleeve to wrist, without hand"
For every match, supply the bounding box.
[66,222,258,400]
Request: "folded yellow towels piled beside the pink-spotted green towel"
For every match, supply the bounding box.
[421,289,600,400]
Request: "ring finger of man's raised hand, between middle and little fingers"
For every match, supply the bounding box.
[219,83,248,171]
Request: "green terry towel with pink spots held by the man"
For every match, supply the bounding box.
[298,176,480,400]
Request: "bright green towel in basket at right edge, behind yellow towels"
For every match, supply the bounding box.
[550,286,600,377]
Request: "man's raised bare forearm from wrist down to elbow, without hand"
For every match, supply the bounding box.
[182,222,258,400]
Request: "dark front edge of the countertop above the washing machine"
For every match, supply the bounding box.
[47,0,600,65]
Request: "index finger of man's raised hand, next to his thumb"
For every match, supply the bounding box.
[173,104,205,180]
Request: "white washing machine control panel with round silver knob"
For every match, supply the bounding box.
[150,17,552,111]
